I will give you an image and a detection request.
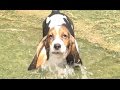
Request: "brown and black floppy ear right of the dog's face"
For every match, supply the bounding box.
[70,35,83,65]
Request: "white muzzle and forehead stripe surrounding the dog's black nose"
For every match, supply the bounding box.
[50,26,66,53]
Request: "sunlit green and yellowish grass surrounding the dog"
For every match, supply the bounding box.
[0,10,120,79]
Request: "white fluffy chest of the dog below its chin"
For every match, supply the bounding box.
[41,55,74,77]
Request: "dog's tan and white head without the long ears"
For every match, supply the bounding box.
[46,25,71,54]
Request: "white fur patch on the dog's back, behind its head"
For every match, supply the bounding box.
[46,14,67,28]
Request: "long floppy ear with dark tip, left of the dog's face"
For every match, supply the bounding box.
[28,36,47,70]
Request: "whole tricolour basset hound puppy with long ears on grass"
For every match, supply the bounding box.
[28,10,87,78]
